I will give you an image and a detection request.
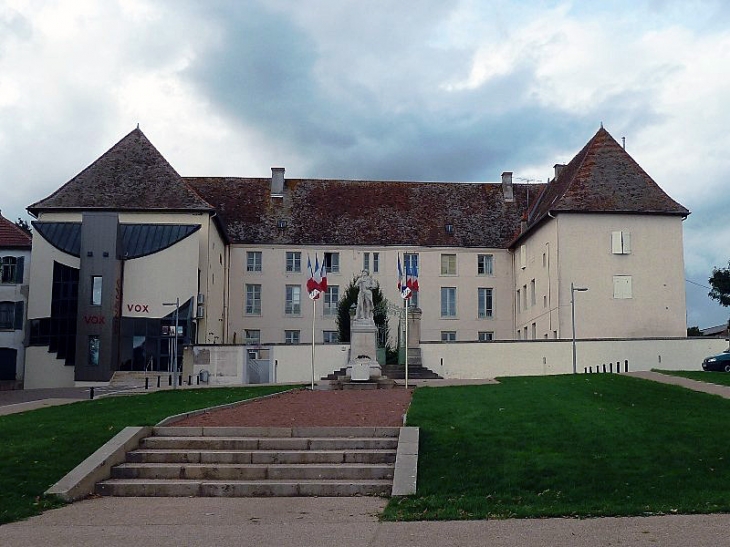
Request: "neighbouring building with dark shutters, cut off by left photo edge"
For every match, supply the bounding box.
[0,215,31,387]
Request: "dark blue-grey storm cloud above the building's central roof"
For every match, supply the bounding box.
[178,3,600,180]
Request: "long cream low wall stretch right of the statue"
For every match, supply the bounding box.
[421,338,728,379]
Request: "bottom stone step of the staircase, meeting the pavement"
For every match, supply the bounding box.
[96,479,393,497]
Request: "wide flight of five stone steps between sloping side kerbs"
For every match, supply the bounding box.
[96,427,400,497]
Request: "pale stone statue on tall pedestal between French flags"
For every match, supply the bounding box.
[347,270,381,382]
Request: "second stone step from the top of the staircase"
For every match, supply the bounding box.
[140,436,398,451]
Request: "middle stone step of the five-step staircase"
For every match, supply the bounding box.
[127,449,396,464]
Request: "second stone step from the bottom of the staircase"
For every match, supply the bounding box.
[112,463,393,481]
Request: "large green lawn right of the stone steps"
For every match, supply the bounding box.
[384,374,730,520]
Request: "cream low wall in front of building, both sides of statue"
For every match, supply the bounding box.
[184,338,728,385]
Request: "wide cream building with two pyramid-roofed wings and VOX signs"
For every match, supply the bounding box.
[21,128,689,387]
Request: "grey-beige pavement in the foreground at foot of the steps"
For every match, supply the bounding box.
[0,498,730,547]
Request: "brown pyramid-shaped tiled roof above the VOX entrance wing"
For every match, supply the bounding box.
[28,128,210,215]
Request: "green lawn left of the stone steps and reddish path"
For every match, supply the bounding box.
[0,386,290,524]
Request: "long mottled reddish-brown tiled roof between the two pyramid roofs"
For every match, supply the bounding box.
[184,177,540,248]
